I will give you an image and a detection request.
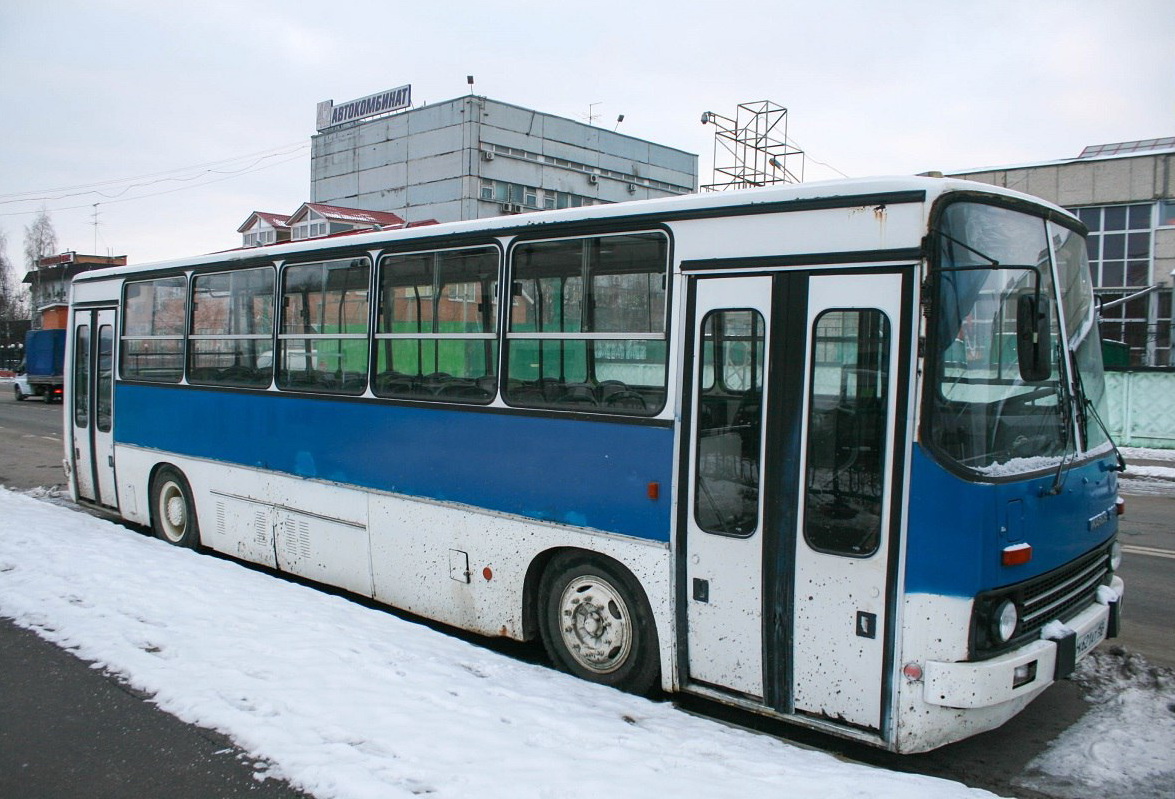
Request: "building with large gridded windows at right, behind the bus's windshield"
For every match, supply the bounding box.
[953,136,1175,367]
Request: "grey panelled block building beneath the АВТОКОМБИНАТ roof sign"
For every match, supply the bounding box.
[310,95,698,223]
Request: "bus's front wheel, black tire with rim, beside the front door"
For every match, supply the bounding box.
[538,552,660,694]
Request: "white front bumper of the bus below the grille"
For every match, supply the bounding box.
[922,577,1124,709]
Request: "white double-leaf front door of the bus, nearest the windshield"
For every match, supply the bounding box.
[678,270,904,731]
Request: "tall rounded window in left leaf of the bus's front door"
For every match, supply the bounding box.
[693,310,764,536]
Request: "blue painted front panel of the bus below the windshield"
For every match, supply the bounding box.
[906,445,1117,597]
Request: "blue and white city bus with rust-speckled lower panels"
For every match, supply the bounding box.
[65,177,1124,752]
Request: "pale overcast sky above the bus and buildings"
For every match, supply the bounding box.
[0,0,1175,267]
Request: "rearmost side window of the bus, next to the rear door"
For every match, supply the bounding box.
[121,275,188,383]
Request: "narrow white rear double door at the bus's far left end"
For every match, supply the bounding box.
[66,308,119,508]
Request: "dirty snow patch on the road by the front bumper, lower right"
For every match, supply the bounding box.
[1015,646,1175,799]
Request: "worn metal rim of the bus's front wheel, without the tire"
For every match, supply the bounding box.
[559,575,632,674]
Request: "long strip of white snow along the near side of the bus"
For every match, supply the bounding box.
[0,491,993,799]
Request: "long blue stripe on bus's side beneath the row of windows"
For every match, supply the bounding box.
[114,383,673,542]
